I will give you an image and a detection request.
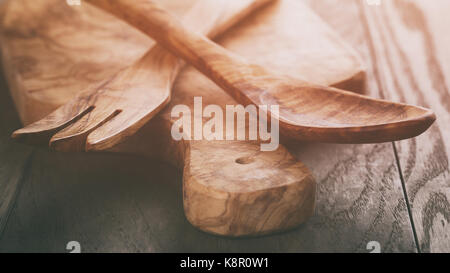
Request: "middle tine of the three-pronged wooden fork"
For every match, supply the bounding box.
[49,107,120,152]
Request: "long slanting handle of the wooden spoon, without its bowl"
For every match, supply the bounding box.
[87,0,253,102]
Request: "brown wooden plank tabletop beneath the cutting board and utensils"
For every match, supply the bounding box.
[0,0,450,252]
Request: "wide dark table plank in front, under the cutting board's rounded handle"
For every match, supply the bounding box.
[0,144,414,252]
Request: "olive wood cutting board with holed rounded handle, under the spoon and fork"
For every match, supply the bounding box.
[2,0,364,236]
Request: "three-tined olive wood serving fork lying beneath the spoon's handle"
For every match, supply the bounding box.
[13,0,273,151]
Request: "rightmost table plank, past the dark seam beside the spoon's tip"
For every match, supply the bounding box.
[360,0,450,252]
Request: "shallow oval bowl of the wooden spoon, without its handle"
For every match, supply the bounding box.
[234,69,436,143]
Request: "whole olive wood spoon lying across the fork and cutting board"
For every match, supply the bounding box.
[81,0,435,143]
